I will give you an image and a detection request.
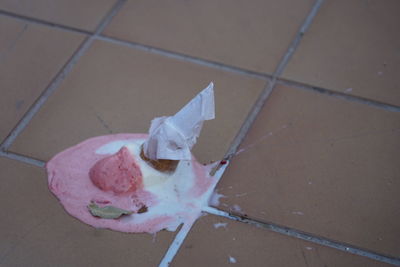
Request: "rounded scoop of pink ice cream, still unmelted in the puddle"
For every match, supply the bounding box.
[89,147,143,194]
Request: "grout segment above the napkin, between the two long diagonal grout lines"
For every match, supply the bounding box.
[96,35,271,80]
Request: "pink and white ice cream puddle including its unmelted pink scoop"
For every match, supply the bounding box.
[46,134,217,233]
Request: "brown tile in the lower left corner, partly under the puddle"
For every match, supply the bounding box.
[0,158,174,266]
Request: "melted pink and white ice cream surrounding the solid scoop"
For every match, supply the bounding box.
[46,134,216,233]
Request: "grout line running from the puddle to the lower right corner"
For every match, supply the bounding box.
[203,207,400,266]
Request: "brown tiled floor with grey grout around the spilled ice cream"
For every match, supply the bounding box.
[0,0,400,266]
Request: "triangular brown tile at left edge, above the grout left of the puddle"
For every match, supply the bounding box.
[0,16,84,142]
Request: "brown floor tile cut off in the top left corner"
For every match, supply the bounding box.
[0,0,116,31]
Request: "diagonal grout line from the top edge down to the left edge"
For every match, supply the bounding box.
[0,0,125,151]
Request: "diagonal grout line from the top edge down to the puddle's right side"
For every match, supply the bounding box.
[224,0,324,160]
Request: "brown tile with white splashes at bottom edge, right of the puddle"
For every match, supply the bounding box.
[171,215,389,267]
